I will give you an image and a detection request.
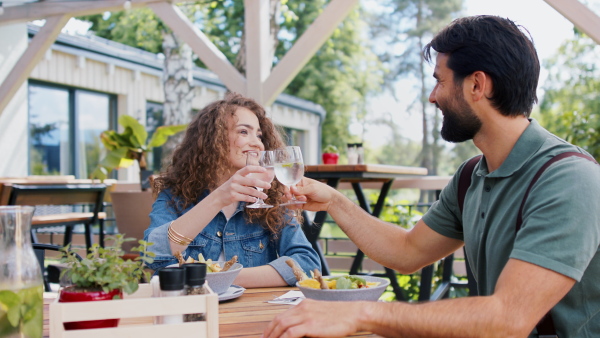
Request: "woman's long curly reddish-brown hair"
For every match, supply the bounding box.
[153,93,292,236]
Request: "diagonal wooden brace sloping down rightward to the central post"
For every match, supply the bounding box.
[148,2,246,95]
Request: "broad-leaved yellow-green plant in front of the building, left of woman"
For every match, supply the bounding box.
[91,115,187,190]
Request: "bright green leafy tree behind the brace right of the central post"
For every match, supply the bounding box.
[276,0,384,149]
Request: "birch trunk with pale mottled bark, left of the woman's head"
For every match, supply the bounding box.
[162,31,194,170]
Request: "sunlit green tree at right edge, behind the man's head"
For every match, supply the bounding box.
[540,31,600,159]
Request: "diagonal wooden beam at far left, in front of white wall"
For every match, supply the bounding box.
[0,15,71,115]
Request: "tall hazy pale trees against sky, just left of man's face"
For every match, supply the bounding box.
[371,0,463,175]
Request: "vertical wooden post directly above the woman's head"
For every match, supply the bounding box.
[244,0,273,104]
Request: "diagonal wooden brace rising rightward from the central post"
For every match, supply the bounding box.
[263,0,359,105]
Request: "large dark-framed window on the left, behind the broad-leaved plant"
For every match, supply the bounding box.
[29,82,116,178]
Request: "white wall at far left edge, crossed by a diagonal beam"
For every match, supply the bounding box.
[0,23,28,177]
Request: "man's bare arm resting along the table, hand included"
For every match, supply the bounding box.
[264,259,575,337]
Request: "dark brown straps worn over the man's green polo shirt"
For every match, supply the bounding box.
[458,151,598,337]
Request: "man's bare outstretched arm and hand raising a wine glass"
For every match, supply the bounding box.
[294,178,463,273]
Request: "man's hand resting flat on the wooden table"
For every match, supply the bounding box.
[263,299,362,338]
